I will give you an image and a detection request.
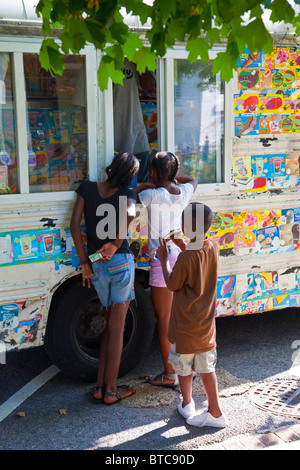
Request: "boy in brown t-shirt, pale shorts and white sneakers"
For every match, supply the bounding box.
[156,203,227,427]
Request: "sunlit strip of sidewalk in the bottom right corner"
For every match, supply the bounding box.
[201,424,300,450]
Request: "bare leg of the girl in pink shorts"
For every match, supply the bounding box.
[151,287,174,384]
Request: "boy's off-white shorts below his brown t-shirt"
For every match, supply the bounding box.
[168,344,217,376]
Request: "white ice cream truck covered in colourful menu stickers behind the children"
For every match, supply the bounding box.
[0,0,300,379]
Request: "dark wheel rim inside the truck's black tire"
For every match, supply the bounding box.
[73,295,137,364]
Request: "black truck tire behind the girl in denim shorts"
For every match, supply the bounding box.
[44,276,154,381]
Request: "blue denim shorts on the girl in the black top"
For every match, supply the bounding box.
[92,253,135,307]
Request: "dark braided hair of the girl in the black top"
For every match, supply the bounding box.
[105,152,140,189]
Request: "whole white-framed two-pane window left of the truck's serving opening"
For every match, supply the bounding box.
[0,44,96,194]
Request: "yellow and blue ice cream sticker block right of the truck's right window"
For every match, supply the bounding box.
[234,47,300,138]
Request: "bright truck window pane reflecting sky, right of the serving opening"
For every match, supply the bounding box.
[174,59,224,184]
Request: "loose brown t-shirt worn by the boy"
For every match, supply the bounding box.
[168,239,219,354]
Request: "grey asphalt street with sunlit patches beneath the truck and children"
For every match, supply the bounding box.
[0,309,300,454]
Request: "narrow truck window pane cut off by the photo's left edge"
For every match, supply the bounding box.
[0,52,18,194]
